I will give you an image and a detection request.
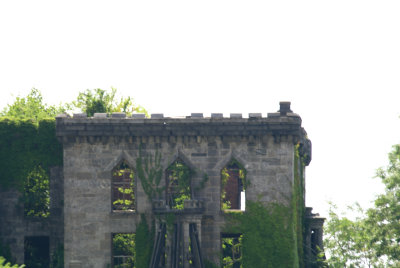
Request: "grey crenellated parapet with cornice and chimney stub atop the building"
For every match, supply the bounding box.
[56,102,311,159]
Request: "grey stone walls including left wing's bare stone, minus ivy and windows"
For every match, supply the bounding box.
[0,102,324,268]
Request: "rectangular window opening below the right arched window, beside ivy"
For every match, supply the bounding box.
[221,234,243,268]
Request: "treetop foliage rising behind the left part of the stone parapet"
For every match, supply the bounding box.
[73,88,147,116]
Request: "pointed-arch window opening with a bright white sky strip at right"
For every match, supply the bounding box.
[221,159,246,211]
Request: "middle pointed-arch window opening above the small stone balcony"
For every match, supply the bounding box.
[166,159,192,209]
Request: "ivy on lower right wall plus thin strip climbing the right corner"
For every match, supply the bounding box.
[224,145,305,268]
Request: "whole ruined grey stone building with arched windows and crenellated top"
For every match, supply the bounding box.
[0,102,323,268]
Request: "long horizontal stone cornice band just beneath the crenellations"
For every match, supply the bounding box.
[56,115,303,137]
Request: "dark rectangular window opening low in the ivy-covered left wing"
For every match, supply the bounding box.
[24,236,50,268]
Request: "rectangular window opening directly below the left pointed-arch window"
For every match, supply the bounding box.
[112,233,136,268]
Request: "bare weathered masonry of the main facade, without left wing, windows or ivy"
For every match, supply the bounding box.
[56,102,322,268]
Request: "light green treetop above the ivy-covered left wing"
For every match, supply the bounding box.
[0,88,69,122]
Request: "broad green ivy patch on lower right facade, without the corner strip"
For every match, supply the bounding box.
[224,201,298,268]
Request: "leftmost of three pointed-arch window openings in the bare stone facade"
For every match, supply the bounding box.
[112,161,135,210]
